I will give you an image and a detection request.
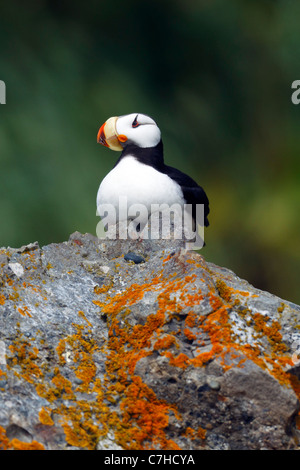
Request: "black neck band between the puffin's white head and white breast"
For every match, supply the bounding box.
[115,141,164,170]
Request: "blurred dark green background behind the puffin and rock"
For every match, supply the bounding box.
[0,0,300,303]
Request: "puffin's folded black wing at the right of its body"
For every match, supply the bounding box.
[166,165,209,227]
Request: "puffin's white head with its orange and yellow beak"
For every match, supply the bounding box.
[97,113,161,151]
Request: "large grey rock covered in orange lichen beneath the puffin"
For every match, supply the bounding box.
[0,232,300,450]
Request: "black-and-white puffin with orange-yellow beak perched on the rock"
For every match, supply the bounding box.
[96,113,209,245]
